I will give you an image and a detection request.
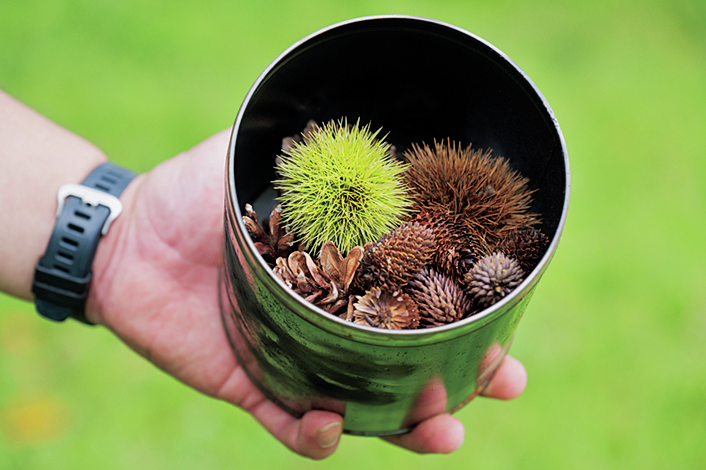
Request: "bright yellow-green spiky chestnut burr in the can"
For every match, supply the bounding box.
[274,119,411,253]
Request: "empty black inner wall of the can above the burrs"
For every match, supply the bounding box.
[232,17,567,242]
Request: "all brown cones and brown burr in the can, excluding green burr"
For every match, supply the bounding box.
[243,135,549,330]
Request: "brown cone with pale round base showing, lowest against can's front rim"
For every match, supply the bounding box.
[352,288,419,330]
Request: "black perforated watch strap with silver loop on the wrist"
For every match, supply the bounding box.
[32,163,136,323]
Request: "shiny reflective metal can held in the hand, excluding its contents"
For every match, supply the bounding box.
[220,16,569,435]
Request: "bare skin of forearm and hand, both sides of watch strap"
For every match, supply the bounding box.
[0,91,527,459]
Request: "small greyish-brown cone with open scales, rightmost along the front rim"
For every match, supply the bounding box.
[464,253,524,309]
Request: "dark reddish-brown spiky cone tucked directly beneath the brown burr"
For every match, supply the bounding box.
[414,209,478,281]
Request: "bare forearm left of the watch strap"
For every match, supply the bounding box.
[0,90,106,299]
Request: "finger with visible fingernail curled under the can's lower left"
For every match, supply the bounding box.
[216,367,343,460]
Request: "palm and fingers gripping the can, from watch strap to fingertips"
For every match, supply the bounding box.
[87,131,527,459]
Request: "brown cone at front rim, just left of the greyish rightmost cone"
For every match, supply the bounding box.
[407,268,472,327]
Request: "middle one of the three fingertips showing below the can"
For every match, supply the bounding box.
[383,413,466,454]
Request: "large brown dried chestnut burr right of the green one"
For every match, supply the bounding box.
[404,141,537,251]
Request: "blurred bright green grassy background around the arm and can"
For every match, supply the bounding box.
[0,0,706,470]
